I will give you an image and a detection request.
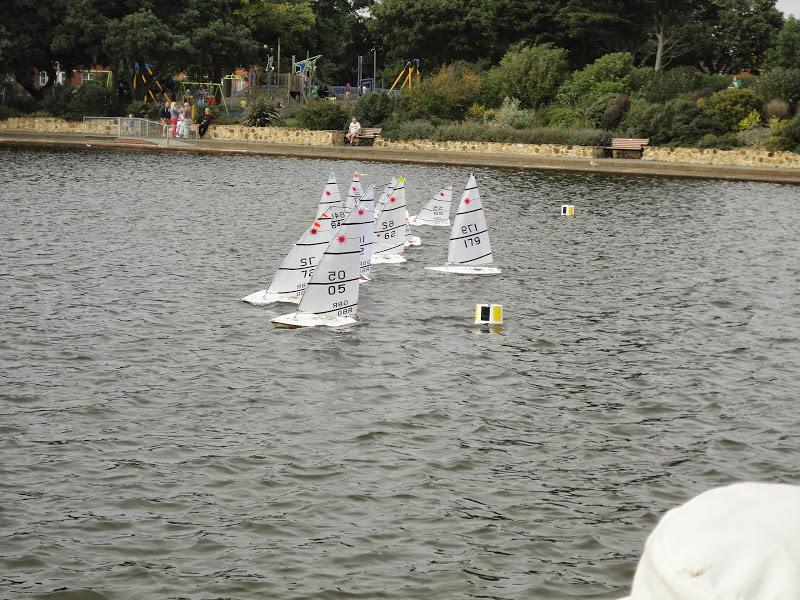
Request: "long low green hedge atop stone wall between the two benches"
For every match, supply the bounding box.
[382,121,611,146]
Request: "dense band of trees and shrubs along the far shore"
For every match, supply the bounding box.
[0,0,800,148]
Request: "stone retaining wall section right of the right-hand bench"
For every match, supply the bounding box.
[642,146,800,169]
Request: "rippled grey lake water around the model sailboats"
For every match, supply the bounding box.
[0,149,800,600]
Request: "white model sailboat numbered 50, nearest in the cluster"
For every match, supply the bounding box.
[272,187,375,329]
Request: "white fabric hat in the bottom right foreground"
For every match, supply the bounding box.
[626,483,800,600]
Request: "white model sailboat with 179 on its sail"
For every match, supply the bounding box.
[425,174,500,275]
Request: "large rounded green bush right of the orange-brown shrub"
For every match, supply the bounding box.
[484,44,567,108]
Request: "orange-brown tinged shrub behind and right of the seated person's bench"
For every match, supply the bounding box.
[406,63,481,120]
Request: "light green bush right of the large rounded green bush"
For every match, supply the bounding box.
[556,52,633,107]
